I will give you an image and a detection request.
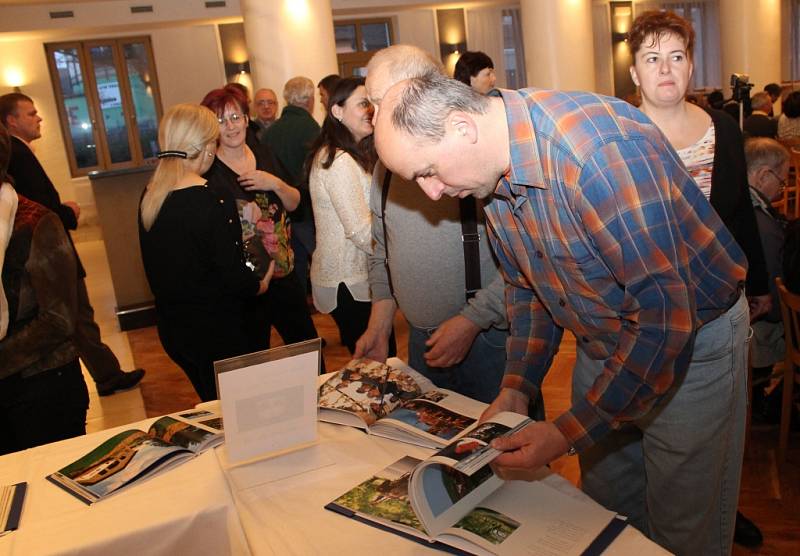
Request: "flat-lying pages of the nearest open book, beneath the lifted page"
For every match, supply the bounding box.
[325,456,615,556]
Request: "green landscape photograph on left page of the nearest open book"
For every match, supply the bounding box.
[333,456,424,532]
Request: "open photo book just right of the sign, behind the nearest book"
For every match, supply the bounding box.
[319,358,487,448]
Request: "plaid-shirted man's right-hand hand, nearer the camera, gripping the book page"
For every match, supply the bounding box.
[491,423,569,481]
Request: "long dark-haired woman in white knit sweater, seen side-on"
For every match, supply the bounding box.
[309,77,394,354]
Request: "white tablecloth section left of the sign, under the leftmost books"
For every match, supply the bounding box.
[0,419,249,556]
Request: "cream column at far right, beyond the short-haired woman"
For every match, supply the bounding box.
[719,0,781,97]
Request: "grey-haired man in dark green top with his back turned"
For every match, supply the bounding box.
[264,77,319,298]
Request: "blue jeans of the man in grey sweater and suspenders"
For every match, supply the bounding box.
[408,323,508,403]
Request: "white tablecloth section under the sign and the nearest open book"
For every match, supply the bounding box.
[216,423,668,556]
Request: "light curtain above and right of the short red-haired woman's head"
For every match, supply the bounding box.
[634,0,722,89]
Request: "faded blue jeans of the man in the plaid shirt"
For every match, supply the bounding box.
[572,295,749,555]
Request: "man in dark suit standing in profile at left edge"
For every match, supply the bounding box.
[0,93,144,396]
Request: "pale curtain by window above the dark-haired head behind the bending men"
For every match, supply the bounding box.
[467,7,527,89]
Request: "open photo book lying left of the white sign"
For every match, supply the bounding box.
[47,409,224,504]
